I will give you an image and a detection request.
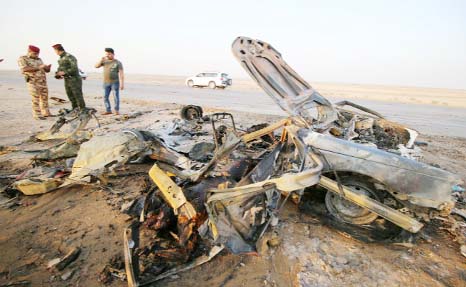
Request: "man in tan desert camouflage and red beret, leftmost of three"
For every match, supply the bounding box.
[18,45,51,120]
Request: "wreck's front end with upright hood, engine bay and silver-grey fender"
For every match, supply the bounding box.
[232,37,461,224]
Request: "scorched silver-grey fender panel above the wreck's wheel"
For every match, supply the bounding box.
[301,131,457,210]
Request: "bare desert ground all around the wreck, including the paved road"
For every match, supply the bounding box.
[0,71,466,286]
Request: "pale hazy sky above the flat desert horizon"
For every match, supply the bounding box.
[0,0,466,89]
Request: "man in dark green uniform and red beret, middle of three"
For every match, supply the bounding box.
[52,44,86,111]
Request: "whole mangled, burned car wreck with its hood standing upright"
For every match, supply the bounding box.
[7,37,462,286]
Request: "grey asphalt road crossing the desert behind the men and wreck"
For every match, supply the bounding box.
[0,71,466,138]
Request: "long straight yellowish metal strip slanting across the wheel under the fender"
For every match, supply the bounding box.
[319,176,424,233]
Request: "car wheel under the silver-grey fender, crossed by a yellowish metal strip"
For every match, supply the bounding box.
[325,177,380,225]
